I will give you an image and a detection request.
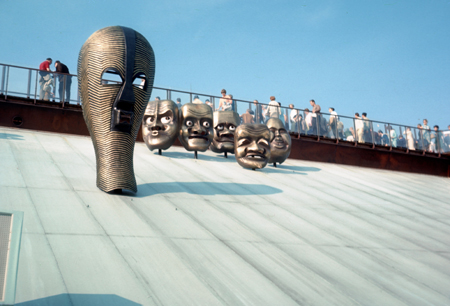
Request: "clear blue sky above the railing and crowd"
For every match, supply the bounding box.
[0,0,450,129]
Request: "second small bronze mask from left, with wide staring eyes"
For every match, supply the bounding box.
[178,103,213,152]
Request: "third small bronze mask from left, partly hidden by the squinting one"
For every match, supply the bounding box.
[210,111,241,153]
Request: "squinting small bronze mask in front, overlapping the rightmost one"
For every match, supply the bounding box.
[234,123,270,170]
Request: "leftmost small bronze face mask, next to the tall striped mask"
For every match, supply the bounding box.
[142,100,179,151]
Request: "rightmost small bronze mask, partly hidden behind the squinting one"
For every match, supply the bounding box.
[267,118,292,167]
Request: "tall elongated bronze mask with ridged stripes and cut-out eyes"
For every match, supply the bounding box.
[78,26,155,192]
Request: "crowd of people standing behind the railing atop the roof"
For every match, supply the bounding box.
[39,58,450,153]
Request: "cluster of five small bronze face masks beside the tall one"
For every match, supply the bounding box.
[142,100,291,170]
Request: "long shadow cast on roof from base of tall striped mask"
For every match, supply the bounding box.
[136,182,283,197]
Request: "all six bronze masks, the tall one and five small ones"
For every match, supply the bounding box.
[77,26,291,193]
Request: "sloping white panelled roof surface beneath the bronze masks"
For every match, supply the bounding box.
[0,128,450,306]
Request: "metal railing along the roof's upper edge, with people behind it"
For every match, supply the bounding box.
[0,64,450,156]
